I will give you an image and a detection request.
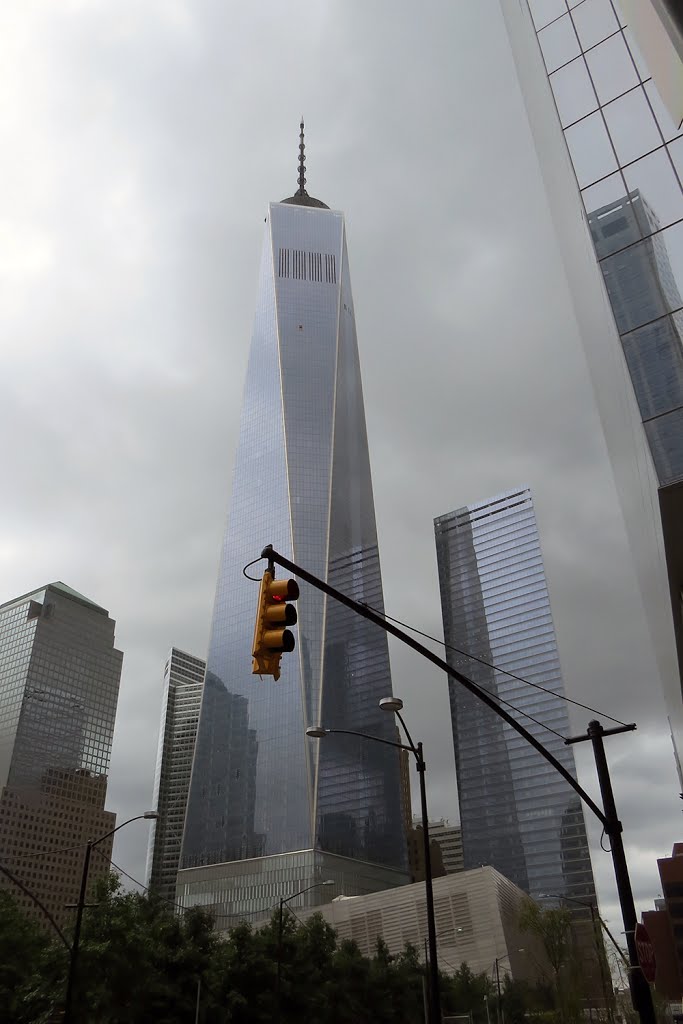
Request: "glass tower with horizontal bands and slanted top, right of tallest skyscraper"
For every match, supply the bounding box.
[434,488,595,899]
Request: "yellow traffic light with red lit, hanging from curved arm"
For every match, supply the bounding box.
[252,569,299,680]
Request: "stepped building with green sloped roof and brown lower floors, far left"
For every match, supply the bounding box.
[0,583,123,924]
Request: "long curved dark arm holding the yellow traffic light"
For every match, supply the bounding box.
[261,545,608,827]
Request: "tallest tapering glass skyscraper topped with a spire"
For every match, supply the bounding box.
[177,126,408,922]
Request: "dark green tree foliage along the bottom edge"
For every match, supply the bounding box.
[0,876,569,1024]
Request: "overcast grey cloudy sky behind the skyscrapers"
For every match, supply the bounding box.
[0,0,681,931]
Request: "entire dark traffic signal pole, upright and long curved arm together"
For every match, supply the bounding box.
[261,545,655,1024]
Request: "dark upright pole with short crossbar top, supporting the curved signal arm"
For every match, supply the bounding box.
[564,719,656,1024]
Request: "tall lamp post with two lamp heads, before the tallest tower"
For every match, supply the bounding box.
[306,697,441,1024]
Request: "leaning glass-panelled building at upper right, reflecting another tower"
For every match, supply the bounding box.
[501,0,683,761]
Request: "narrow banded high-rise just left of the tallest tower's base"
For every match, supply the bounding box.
[147,647,206,900]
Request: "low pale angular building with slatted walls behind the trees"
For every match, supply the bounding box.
[293,867,550,978]
